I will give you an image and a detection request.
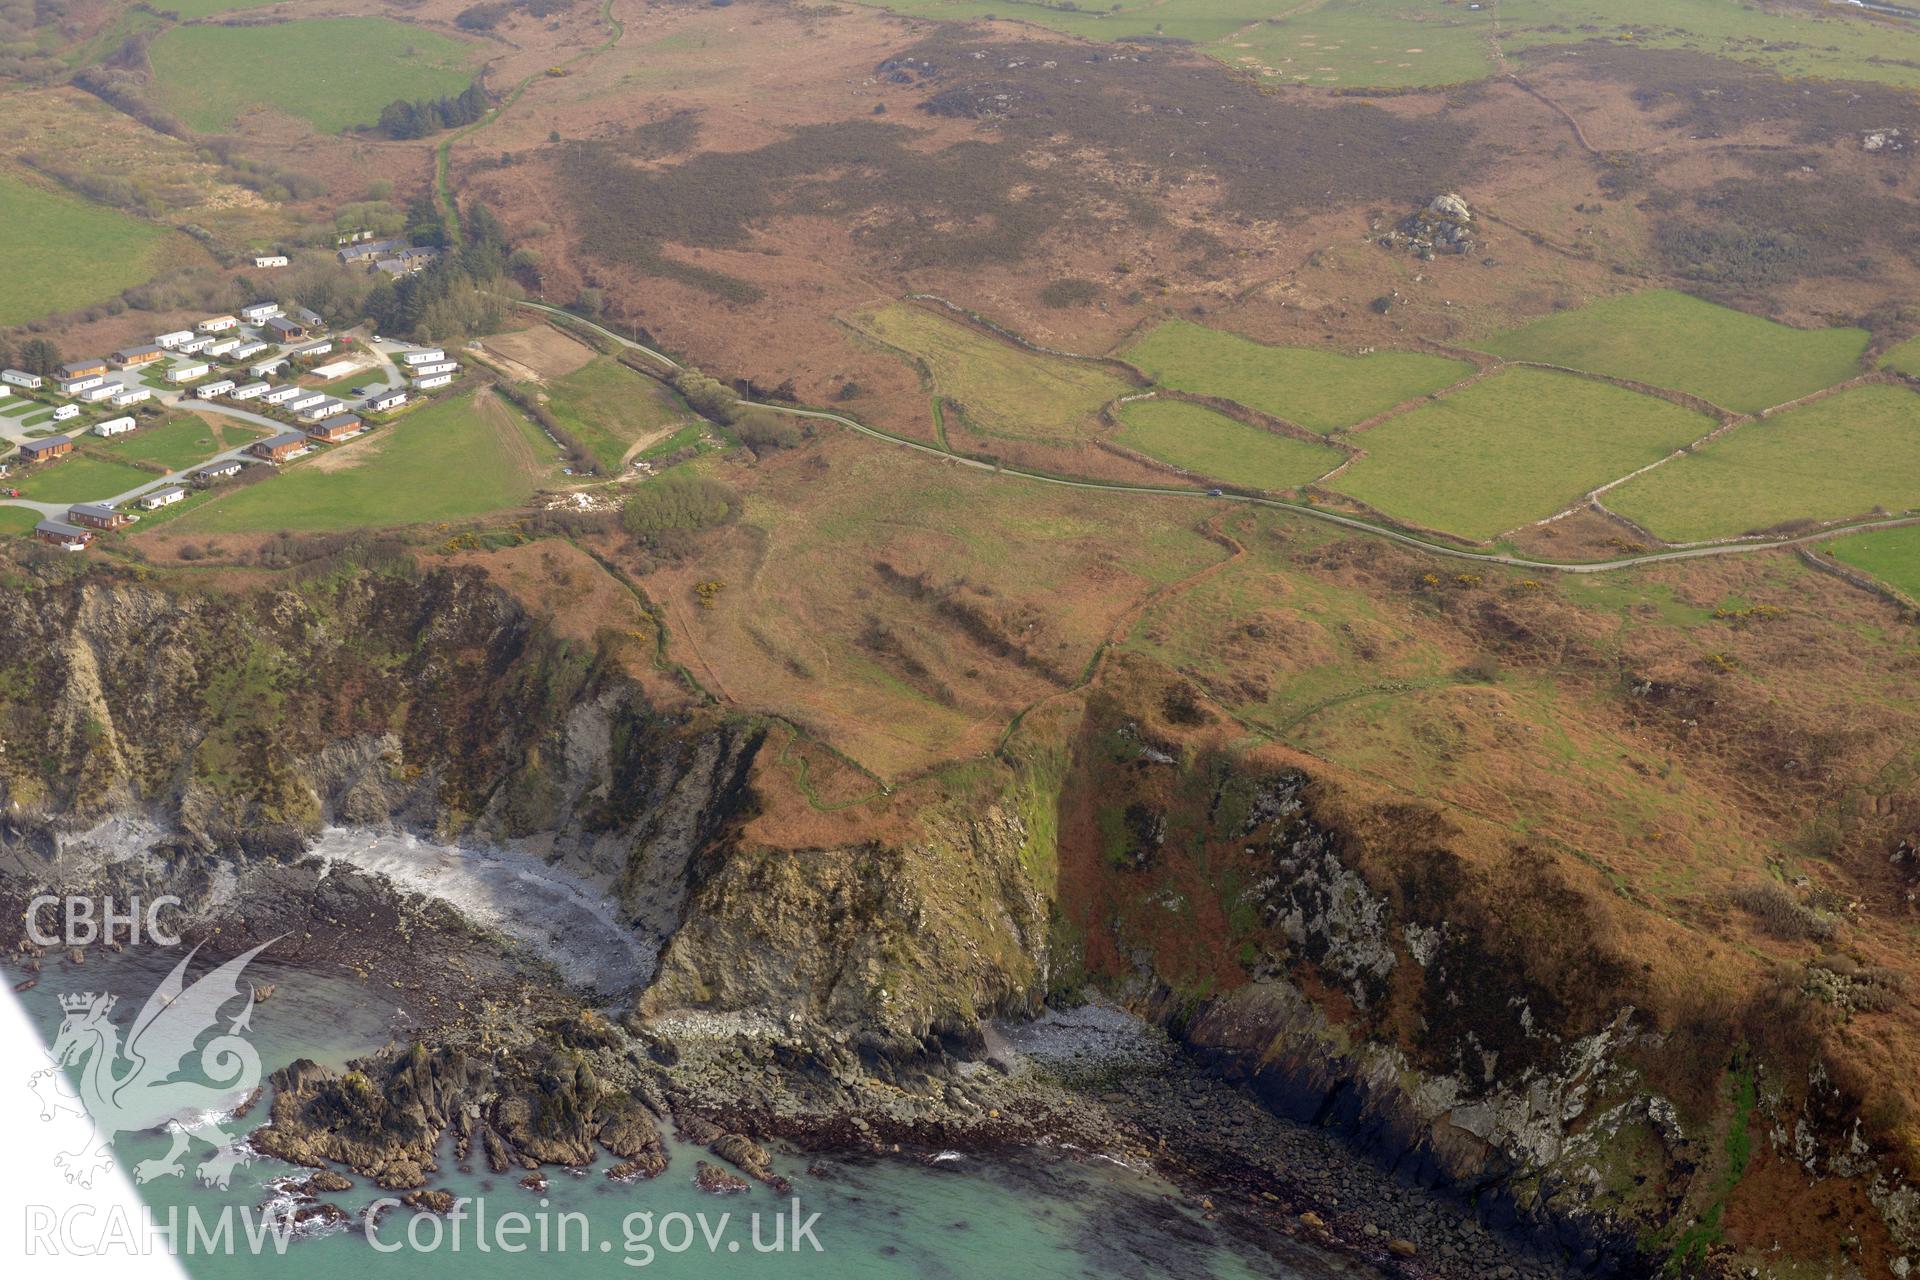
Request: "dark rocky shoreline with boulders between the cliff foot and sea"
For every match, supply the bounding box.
[0,840,1592,1280]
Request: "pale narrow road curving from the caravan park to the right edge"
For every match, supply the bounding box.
[513,299,1920,574]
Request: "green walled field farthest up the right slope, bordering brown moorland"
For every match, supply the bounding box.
[1480,290,1868,413]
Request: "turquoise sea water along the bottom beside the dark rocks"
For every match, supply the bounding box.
[7,952,1379,1280]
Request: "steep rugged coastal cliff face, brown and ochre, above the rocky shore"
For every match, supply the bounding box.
[0,564,1920,1274]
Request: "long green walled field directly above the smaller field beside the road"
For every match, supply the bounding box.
[1121,320,1473,432]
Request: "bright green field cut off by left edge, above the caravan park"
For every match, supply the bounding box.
[0,171,169,324]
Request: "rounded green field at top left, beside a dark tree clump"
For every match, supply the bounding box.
[148,17,476,132]
